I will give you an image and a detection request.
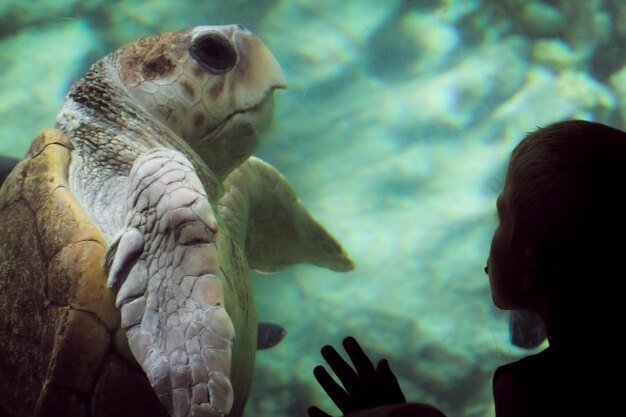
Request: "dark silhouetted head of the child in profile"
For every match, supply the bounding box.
[489,120,626,310]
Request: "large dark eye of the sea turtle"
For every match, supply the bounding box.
[189,33,237,74]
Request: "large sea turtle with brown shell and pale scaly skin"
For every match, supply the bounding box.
[0,25,353,417]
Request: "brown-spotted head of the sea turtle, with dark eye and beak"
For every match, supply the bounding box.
[113,25,286,178]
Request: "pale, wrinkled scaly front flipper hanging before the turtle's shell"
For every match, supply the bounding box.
[105,148,234,417]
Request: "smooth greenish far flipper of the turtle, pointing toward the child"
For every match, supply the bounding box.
[220,157,354,272]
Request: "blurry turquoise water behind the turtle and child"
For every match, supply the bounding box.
[0,0,626,417]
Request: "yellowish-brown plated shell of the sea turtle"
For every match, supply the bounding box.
[0,129,168,417]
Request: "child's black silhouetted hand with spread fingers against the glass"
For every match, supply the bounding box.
[308,337,445,417]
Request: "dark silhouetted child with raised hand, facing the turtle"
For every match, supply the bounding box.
[308,120,626,417]
